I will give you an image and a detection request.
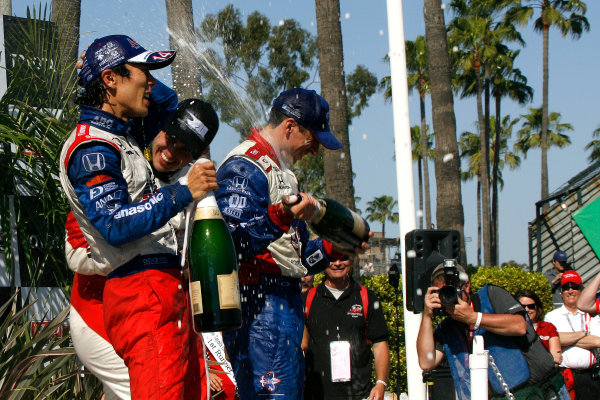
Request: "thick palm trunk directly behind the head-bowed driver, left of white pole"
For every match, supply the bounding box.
[315,0,354,209]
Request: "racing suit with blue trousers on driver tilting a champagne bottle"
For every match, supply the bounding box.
[216,130,342,400]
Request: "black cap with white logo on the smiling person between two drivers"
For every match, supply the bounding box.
[165,99,219,158]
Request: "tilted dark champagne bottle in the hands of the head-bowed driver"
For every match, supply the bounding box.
[308,199,371,252]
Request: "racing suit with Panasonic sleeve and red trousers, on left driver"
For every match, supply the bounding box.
[61,107,206,399]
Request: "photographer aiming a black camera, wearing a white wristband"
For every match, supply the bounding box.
[417,260,569,399]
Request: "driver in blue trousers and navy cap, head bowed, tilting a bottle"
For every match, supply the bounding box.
[216,88,368,400]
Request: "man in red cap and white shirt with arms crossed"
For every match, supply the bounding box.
[544,270,600,400]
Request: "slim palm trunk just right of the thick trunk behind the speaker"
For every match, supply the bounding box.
[475,63,492,265]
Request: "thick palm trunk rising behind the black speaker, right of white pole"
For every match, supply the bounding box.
[423,0,467,264]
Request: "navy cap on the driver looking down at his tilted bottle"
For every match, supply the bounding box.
[273,88,342,150]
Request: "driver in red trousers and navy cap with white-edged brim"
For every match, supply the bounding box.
[60,35,217,400]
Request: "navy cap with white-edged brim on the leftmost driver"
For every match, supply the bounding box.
[79,35,176,87]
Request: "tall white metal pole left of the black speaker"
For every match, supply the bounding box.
[387,0,425,400]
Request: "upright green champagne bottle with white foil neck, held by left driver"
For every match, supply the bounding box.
[188,193,242,332]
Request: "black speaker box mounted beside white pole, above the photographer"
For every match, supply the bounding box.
[404,229,460,312]
